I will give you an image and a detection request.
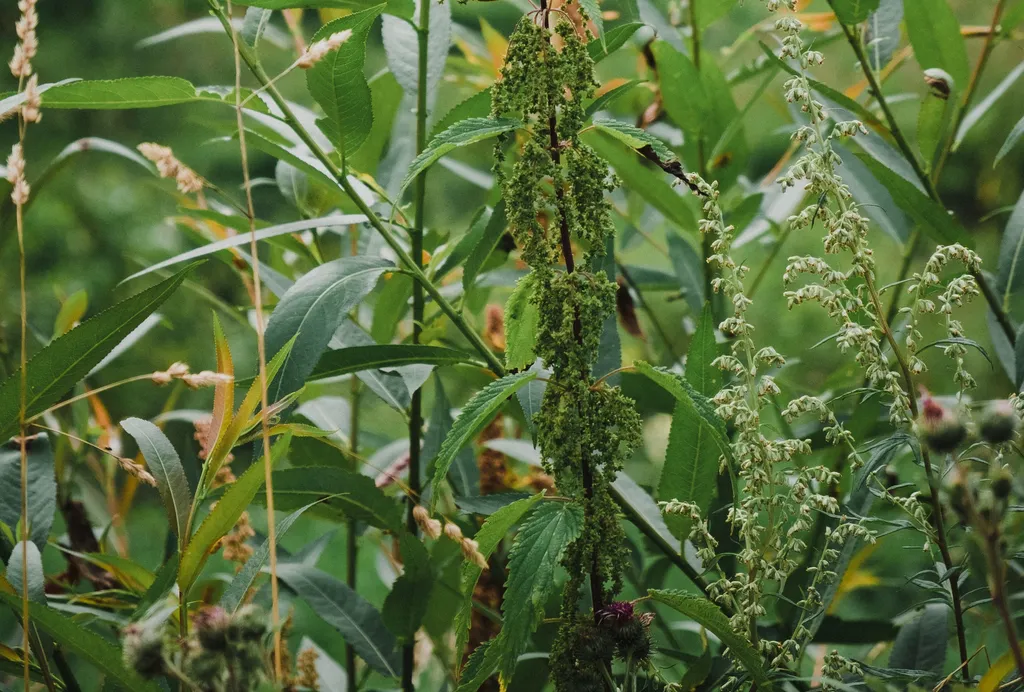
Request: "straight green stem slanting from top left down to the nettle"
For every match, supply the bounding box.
[209,5,505,376]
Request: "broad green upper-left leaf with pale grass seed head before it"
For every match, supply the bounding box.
[306,5,384,157]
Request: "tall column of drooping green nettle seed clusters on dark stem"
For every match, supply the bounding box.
[493,14,641,691]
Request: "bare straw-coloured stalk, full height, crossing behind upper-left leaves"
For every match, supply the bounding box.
[226,0,284,680]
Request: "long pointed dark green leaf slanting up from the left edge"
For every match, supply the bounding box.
[0,267,191,439]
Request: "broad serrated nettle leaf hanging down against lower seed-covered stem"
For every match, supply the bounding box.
[495,503,584,689]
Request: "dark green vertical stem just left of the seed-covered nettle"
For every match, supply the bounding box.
[401,0,433,692]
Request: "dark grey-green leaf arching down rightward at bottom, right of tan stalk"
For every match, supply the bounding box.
[278,564,399,678]
